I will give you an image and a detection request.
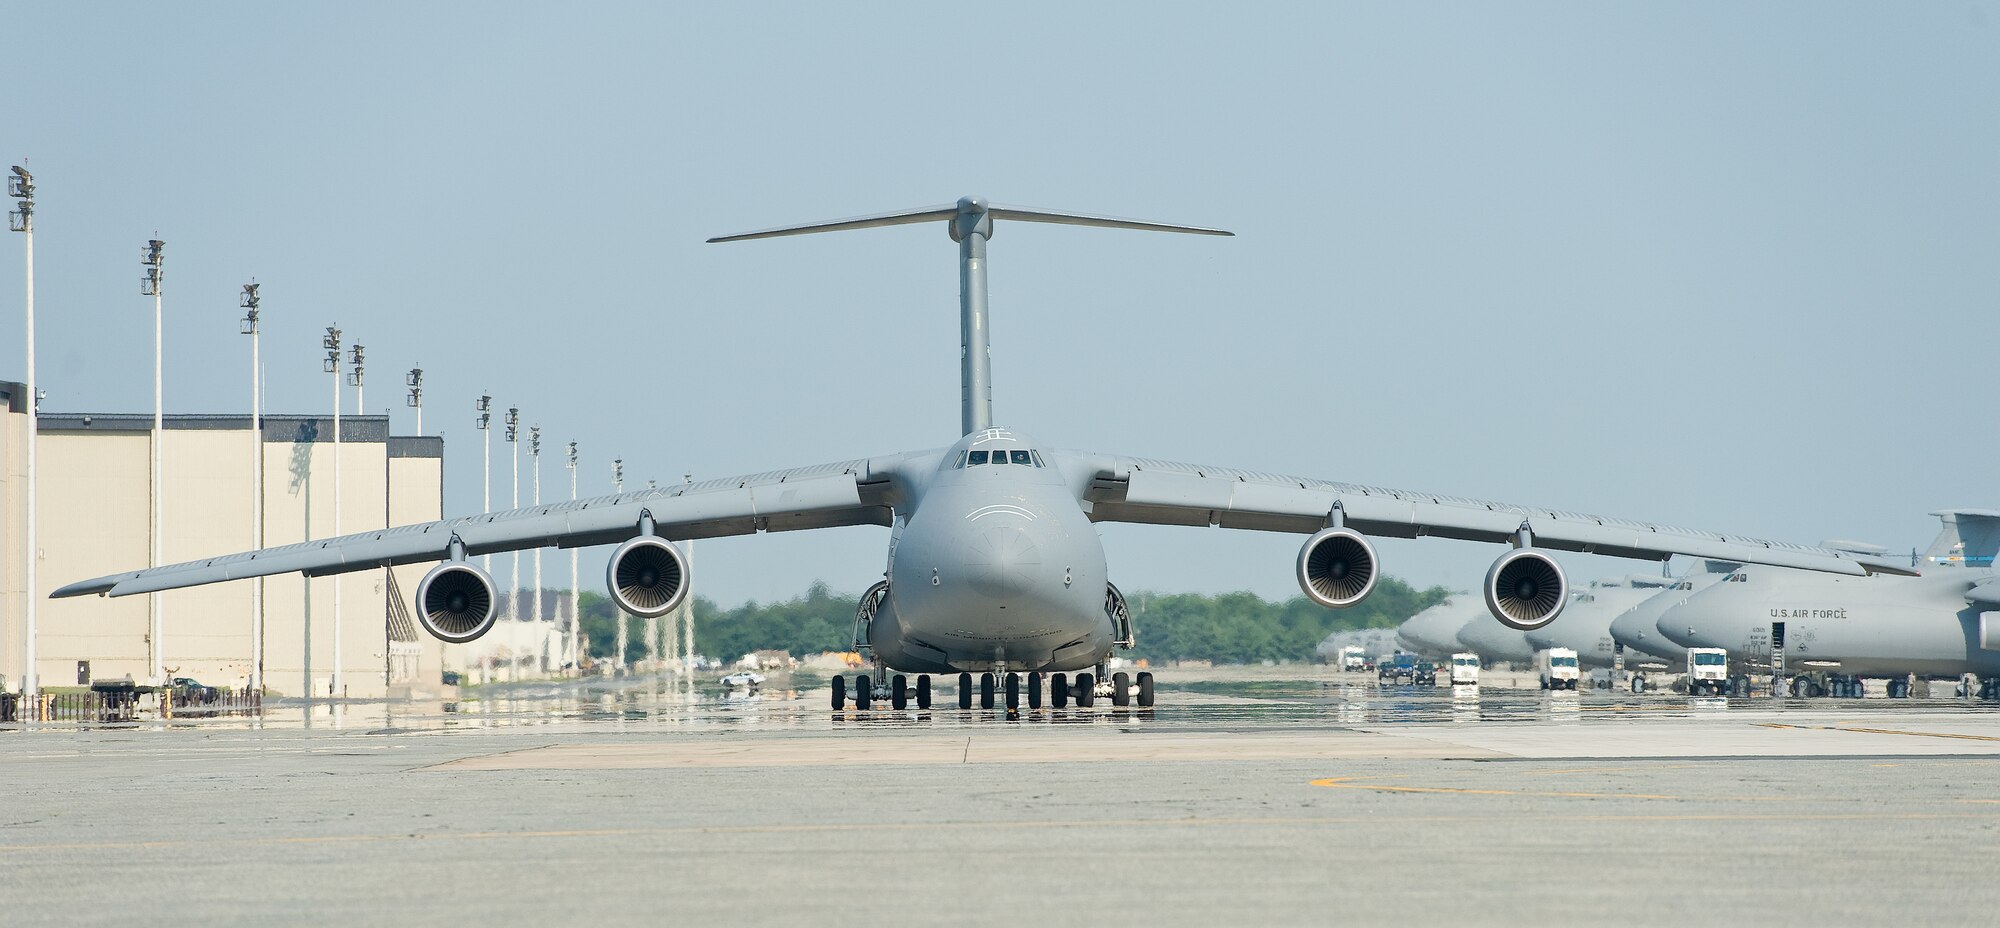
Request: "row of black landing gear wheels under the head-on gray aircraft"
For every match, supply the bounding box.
[832,670,1154,712]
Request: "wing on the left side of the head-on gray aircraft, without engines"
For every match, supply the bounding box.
[50,452,940,598]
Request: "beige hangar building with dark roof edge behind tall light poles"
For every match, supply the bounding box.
[0,382,456,698]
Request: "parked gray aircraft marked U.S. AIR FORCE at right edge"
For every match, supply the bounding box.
[1656,510,2000,698]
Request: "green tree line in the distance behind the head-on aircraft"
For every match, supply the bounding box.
[582,576,1450,664]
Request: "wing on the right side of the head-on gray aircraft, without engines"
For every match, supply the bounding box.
[1052,450,1916,576]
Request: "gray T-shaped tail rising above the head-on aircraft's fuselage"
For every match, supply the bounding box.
[708,196,1234,434]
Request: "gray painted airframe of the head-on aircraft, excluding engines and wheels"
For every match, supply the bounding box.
[52,198,1904,672]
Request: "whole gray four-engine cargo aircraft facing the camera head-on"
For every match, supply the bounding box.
[54,198,1906,708]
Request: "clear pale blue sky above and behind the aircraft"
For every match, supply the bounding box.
[0,2,2000,602]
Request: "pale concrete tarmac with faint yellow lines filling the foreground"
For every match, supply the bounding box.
[0,668,2000,926]
